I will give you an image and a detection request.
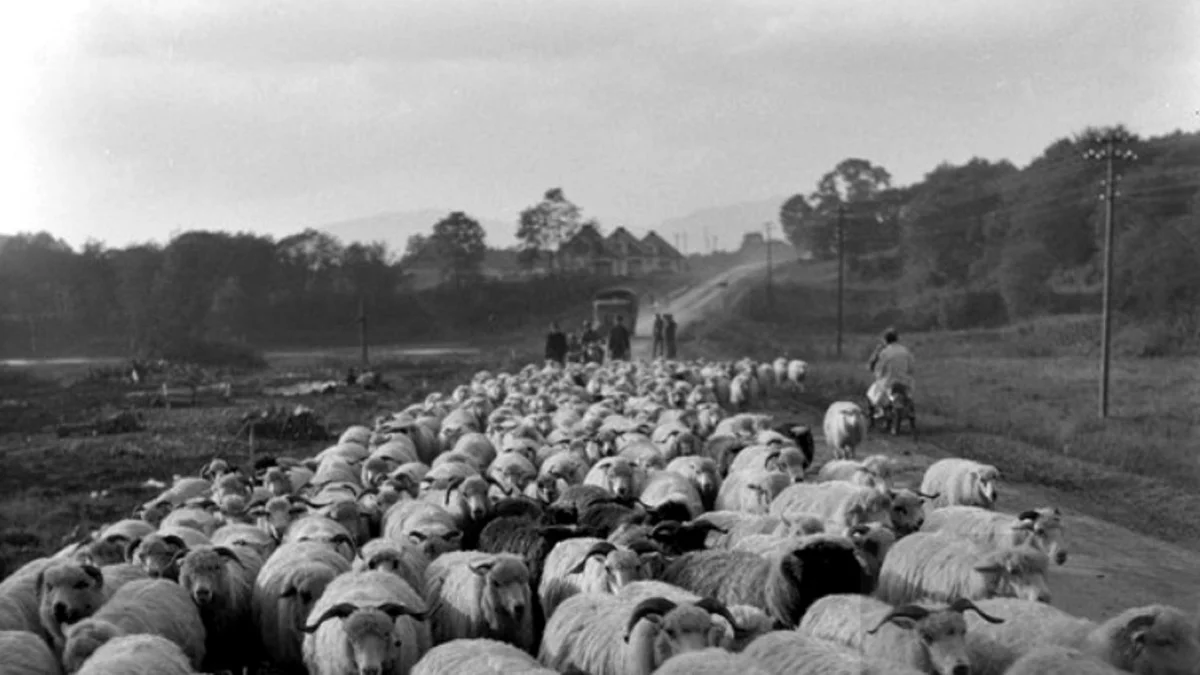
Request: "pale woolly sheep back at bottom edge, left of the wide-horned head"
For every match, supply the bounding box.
[742,631,924,675]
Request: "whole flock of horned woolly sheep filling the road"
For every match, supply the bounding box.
[0,359,1200,675]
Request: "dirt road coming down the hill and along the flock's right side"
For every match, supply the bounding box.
[652,263,1200,620]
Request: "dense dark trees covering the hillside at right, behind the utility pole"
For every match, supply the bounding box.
[780,127,1200,340]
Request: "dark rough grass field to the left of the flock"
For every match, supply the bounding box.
[0,345,534,578]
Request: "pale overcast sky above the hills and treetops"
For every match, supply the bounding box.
[0,0,1200,245]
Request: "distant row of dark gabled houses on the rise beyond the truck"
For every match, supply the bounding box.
[557,225,686,276]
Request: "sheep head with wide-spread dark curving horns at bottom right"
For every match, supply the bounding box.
[866,598,1004,673]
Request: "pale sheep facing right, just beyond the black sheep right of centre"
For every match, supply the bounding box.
[769,480,893,527]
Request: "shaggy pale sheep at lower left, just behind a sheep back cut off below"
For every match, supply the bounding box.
[62,579,205,673]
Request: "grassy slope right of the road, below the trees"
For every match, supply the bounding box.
[685,260,1200,550]
